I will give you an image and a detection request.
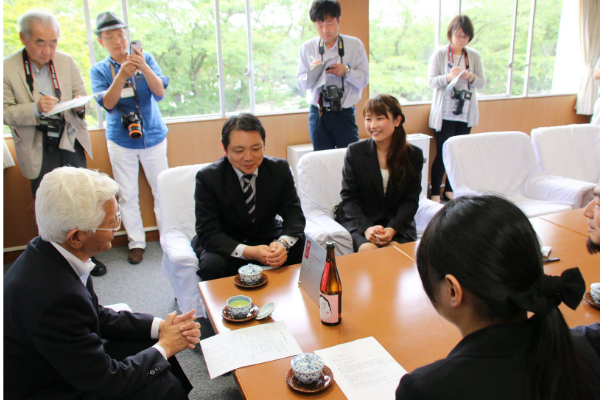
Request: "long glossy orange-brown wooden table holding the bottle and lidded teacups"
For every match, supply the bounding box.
[199,218,600,399]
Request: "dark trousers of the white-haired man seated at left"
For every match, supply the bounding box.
[104,339,192,400]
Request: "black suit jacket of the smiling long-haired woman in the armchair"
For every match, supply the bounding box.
[340,139,423,241]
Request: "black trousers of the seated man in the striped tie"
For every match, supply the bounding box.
[192,235,305,281]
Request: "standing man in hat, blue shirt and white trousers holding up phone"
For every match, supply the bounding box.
[90,12,169,264]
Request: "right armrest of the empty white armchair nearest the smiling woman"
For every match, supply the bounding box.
[523,172,594,208]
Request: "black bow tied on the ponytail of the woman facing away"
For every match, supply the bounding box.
[508,268,585,315]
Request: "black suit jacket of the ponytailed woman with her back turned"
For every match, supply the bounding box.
[396,321,600,400]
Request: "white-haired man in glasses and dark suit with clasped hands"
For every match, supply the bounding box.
[4,167,200,400]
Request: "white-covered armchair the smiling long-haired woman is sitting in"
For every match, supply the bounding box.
[297,149,443,254]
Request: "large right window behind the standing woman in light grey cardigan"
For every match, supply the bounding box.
[369,0,576,103]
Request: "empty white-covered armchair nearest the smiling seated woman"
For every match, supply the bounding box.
[443,132,594,218]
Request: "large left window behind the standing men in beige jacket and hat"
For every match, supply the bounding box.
[3,0,316,126]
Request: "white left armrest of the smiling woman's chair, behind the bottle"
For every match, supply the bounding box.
[304,211,354,255]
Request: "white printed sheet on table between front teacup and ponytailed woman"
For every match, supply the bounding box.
[315,336,406,400]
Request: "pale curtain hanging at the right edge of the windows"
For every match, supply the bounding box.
[575,0,600,115]
